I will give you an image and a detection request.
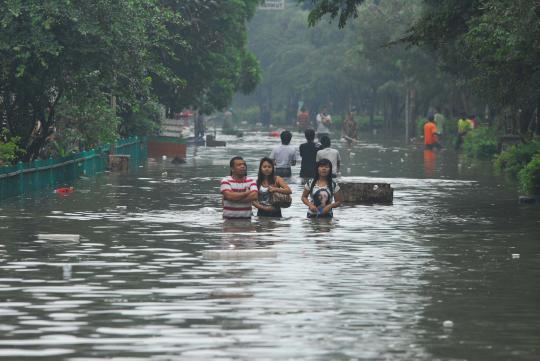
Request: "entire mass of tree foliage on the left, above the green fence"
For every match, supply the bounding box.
[0,0,260,160]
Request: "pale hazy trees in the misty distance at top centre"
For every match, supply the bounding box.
[236,0,452,134]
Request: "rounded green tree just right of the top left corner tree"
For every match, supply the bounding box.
[153,0,260,112]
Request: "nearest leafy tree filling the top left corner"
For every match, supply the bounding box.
[0,0,169,159]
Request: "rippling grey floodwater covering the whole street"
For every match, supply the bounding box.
[0,133,540,361]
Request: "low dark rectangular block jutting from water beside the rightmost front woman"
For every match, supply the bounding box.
[339,182,394,204]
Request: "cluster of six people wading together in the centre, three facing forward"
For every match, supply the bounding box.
[220,125,342,219]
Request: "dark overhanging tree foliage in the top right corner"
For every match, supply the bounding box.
[300,0,540,139]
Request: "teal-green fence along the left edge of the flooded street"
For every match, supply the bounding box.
[0,137,148,200]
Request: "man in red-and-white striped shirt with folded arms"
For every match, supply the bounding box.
[221,157,258,219]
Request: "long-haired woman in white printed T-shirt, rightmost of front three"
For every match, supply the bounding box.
[302,159,343,218]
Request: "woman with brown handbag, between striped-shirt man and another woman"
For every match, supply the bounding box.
[253,157,292,217]
